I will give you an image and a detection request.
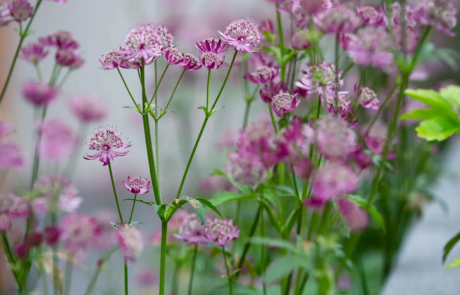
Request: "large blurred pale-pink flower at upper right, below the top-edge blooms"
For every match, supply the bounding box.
[346,27,393,68]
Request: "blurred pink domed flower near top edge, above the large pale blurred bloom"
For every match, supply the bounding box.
[314,5,360,34]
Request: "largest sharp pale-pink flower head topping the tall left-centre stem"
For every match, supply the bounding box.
[121,25,173,65]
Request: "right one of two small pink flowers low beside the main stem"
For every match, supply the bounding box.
[204,219,240,246]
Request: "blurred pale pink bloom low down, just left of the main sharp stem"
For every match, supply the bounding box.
[116,224,144,261]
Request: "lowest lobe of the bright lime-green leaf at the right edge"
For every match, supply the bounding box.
[415,117,460,141]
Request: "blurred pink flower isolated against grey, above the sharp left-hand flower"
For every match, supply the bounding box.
[69,96,108,123]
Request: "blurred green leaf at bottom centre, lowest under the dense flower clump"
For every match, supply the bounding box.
[262,255,312,284]
